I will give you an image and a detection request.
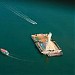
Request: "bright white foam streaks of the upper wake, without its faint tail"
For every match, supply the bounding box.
[8,7,37,24]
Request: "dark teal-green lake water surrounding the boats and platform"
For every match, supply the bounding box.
[0,1,74,75]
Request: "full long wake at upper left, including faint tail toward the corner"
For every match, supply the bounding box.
[1,3,37,24]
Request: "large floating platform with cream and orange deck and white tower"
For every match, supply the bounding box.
[31,32,63,56]
